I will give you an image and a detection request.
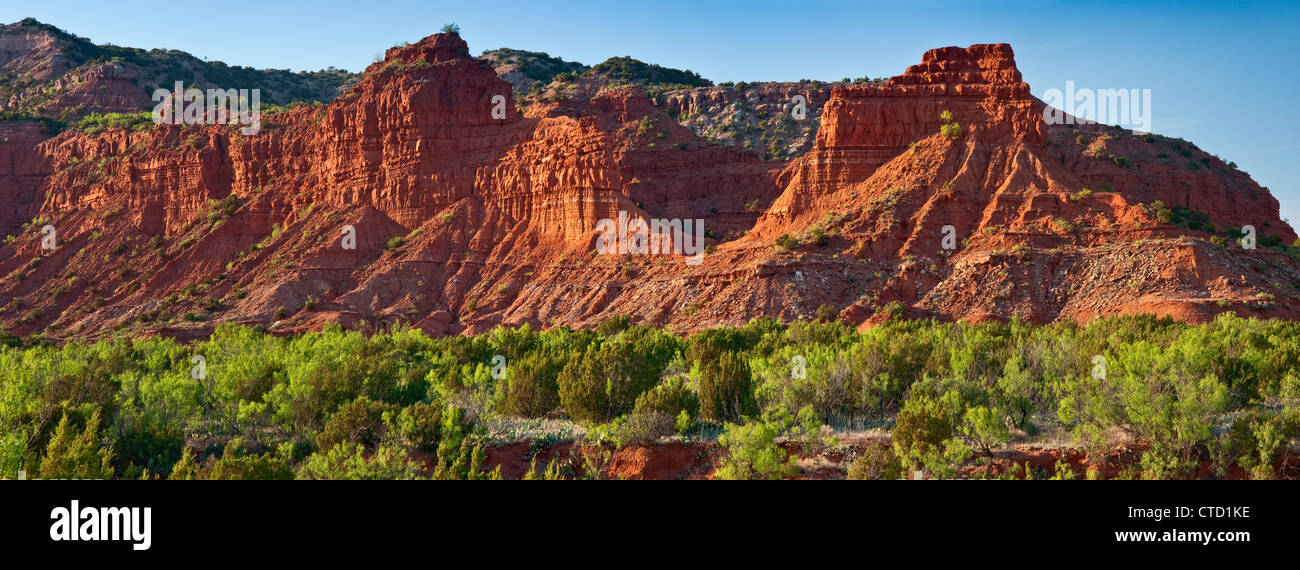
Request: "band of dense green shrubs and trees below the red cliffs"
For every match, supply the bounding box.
[0,314,1300,479]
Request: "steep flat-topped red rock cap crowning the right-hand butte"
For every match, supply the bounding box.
[816,44,1045,153]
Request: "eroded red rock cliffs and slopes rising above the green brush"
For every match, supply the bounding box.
[0,28,1300,346]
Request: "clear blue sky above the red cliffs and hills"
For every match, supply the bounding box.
[10,0,1300,224]
